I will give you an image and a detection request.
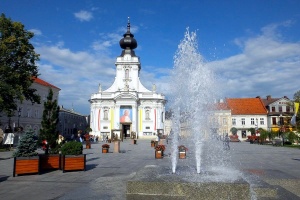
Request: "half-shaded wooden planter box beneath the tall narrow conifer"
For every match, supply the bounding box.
[39,154,62,171]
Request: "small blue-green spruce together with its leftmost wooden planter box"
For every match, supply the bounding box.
[13,130,40,177]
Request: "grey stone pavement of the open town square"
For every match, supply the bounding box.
[0,140,300,200]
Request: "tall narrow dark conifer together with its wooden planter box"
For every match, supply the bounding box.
[39,88,63,170]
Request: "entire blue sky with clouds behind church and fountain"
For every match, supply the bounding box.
[0,0,300,114]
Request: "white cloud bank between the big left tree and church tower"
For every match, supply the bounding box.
[36,46,115,114]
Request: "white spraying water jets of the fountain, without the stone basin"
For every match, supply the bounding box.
[171,29,222,174]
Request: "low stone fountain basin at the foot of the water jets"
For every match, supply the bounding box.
[126,166,251,200]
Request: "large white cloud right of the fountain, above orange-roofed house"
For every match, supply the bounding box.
[208,22,300,98]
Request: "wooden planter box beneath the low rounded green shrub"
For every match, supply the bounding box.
[62,154,86,172]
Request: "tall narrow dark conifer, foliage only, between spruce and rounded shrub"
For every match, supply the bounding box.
[39,88,59,154]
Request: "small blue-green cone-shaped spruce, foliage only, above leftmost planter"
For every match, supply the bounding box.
[13,130,38,157]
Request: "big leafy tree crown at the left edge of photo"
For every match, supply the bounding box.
[0,14,40,117]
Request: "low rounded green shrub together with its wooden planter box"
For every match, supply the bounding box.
[61,141,86,172]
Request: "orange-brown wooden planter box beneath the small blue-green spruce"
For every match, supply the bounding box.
[13,156,40,177]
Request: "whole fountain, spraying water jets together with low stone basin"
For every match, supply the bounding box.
[126,29,262,199]
